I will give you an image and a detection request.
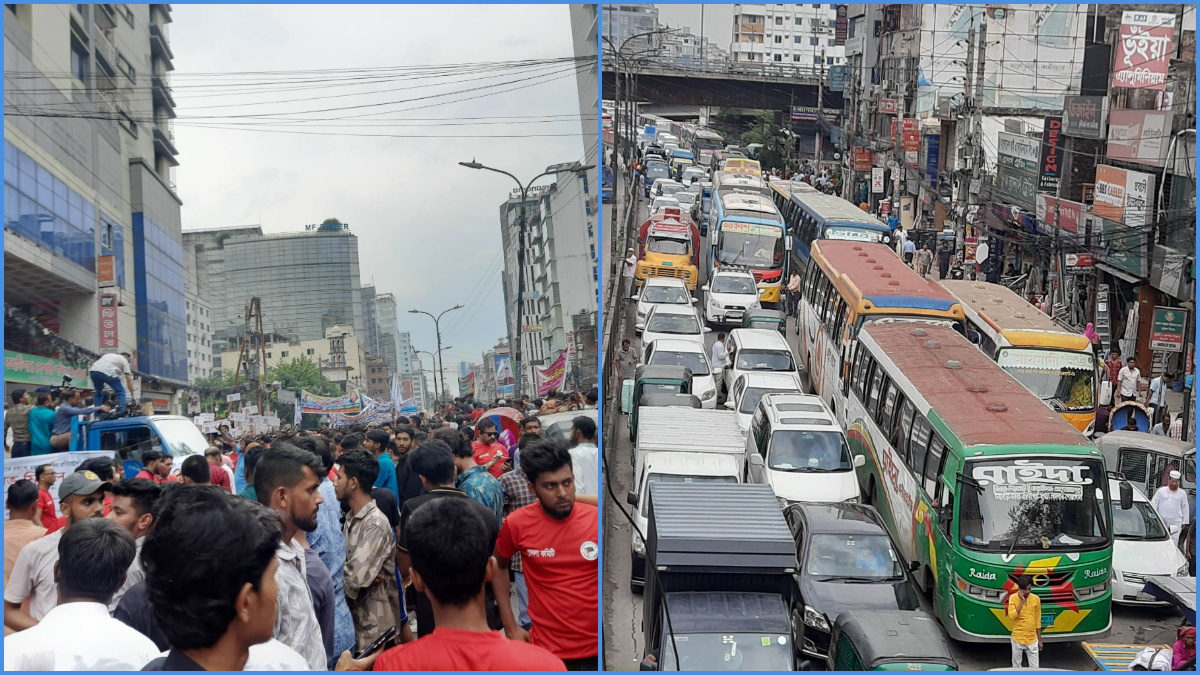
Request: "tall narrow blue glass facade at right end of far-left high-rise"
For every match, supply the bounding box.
[133,211,187,382]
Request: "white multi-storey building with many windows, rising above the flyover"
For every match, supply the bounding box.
[730,5,846,71]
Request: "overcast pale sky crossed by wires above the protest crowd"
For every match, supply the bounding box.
[170,5,595,390]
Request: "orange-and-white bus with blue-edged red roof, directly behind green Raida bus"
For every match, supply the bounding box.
[797,239,966,423]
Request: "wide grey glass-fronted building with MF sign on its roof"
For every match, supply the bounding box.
[184,221,366,347]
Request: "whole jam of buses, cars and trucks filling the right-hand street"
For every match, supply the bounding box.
[605,114,1195,670]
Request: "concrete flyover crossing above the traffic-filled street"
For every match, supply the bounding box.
[604,58,842,110]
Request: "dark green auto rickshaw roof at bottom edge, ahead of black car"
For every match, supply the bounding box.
[826,609,959,670]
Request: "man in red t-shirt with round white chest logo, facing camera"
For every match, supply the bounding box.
[492,440,600,670]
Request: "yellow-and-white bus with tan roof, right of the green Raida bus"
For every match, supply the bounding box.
[942,281,1099,435]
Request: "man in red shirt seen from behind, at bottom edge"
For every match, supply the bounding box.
[374,498,564,670]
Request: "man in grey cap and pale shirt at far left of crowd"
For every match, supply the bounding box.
[4,471,113,631]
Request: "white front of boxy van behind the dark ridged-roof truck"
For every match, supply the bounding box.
[625,452,742,593]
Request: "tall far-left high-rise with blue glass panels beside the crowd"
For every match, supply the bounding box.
[4,5,188,412]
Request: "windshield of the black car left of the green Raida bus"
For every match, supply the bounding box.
[804,534,904,583]
